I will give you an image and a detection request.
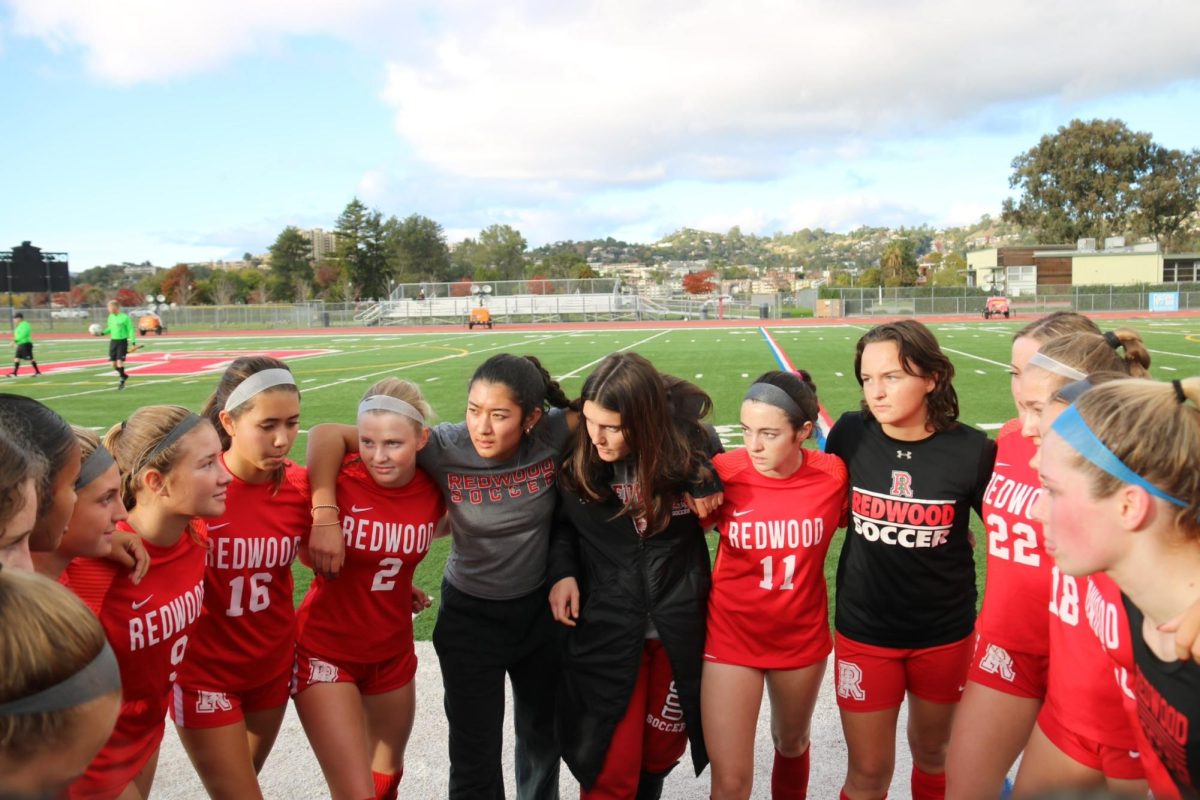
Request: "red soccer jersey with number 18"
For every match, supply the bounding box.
[1045,567,1139,751]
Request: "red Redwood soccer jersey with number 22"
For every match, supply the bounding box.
[976,420,1054,656]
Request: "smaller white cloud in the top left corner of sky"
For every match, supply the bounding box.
[8,0,386,84]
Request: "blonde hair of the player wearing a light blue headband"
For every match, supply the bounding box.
[1075,378,1200,540]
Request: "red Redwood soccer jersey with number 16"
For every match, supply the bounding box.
[179,456,312,692]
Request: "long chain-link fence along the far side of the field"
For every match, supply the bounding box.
[12,278,1200,336]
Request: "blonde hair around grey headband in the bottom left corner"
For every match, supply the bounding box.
[0,570,112,759]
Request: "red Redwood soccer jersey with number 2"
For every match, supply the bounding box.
[298,456,445,663]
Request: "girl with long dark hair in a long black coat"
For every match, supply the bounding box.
[550,353,712,800]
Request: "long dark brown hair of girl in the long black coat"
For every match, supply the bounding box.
[558,353,713,535]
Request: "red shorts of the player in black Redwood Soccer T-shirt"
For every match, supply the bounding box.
[834,633,974,711]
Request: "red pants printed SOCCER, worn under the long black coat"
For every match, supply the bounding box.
[580,639,688,800]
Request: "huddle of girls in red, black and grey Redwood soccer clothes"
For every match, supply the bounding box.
[0,312,1200,800]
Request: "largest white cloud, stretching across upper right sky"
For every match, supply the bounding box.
[384,0,1200,184]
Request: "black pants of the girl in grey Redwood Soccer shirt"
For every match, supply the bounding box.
[433,579,559,800]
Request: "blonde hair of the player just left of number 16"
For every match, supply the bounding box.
[104,405,212,532]
